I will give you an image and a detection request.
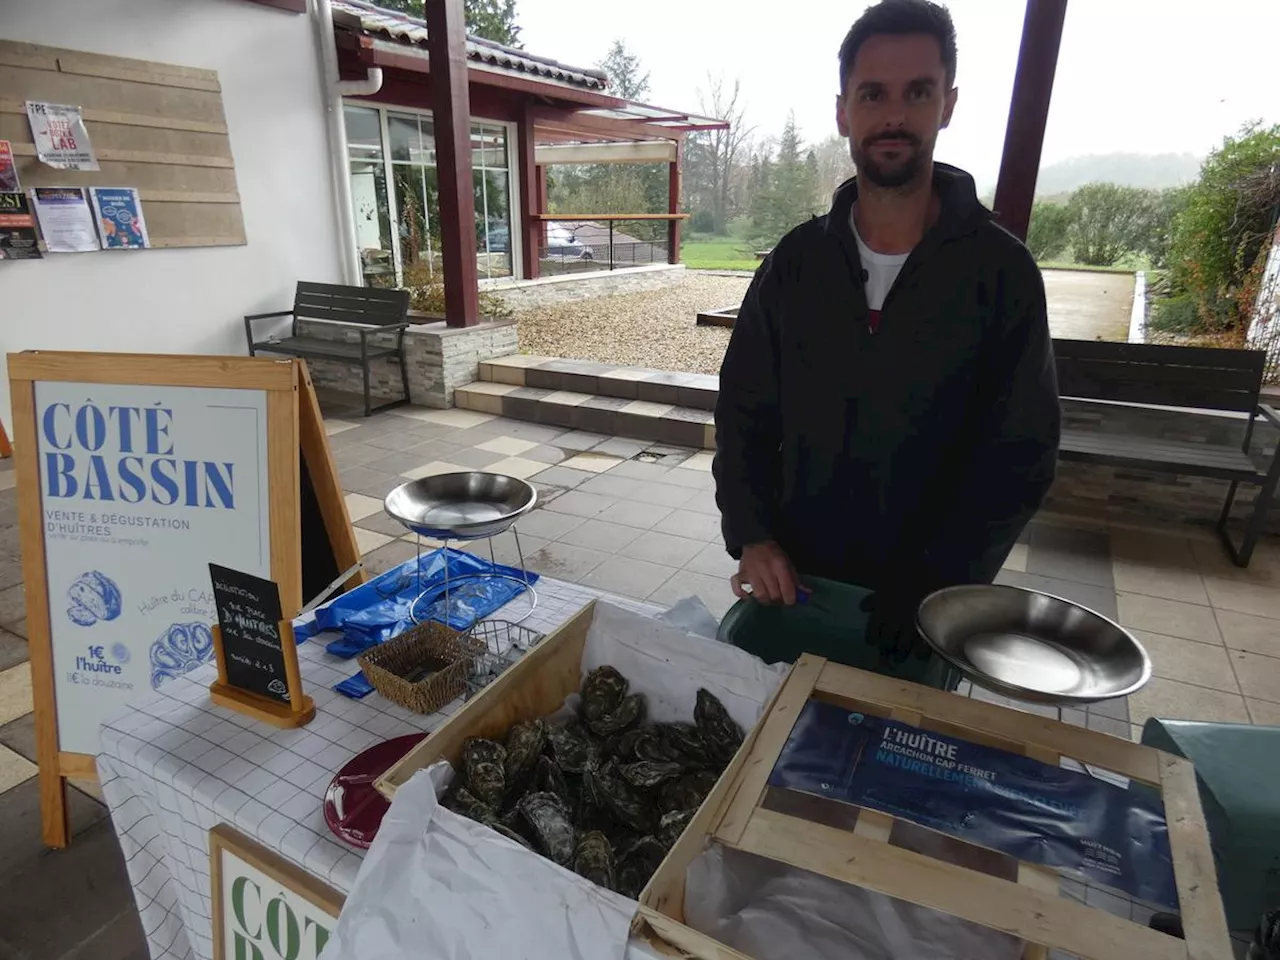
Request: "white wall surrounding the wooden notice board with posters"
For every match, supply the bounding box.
[0,0,342,424]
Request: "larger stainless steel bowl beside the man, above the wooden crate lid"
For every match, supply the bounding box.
[916,584,1151,704]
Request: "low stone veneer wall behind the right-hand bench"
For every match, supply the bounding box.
[1044,399,1280,534]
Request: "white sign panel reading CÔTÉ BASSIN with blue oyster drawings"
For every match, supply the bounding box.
[35,378,271,754]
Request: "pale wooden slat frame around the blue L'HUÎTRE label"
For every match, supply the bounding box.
[635,655,1231,960]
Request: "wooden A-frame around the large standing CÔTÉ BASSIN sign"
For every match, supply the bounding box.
[8,351,364,847]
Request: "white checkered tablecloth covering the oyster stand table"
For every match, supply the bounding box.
[97,577,659,960]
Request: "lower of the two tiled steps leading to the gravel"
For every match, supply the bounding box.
[453,378,716,451]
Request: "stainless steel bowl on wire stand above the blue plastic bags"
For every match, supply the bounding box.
[383,470,538,540]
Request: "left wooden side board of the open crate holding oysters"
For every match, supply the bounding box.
[375,600,595,800]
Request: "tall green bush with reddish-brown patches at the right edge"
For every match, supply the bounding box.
[1169,123,1280,334]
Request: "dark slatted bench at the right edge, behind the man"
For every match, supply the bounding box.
[1053,339,1280,567]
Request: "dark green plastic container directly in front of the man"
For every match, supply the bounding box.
[717,577,960,690]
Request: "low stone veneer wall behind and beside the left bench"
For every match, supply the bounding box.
[298,313,520,408]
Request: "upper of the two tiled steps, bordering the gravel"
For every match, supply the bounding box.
[480,353,719,410]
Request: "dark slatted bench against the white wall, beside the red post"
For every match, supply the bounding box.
[244,280,408,416]
